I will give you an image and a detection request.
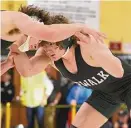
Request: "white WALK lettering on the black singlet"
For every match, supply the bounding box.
[76,71,109,87]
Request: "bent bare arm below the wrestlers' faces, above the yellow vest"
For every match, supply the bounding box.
[14,48,50,77]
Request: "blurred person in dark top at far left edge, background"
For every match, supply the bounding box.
[1,72,15,128]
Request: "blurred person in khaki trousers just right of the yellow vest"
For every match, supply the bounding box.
[45,65,61,128]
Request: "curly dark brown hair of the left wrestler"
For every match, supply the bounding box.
[19,5,51,25]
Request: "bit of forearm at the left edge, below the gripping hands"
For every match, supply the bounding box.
[1,60,14,75]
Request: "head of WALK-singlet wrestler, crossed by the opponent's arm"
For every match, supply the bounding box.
[40,15,76,61]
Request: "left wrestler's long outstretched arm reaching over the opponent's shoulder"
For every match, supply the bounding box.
[2,11,103,42]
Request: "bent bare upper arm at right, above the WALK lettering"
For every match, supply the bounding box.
[81,36,124,78]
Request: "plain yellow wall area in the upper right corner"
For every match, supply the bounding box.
[100,0,131,43]
